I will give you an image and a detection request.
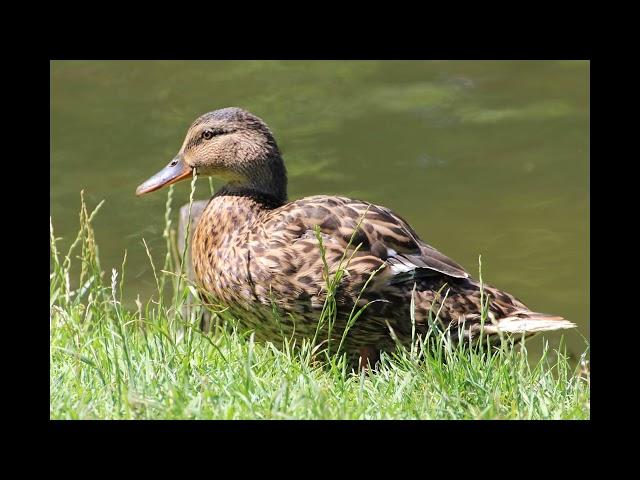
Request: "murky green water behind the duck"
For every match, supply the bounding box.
[50,61,589,353]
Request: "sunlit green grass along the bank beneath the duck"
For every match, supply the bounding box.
[50,190,590,419]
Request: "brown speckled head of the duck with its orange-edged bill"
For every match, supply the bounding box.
[136,107,287,202]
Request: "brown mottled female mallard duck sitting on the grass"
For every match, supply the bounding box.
[136,108,575,366]
